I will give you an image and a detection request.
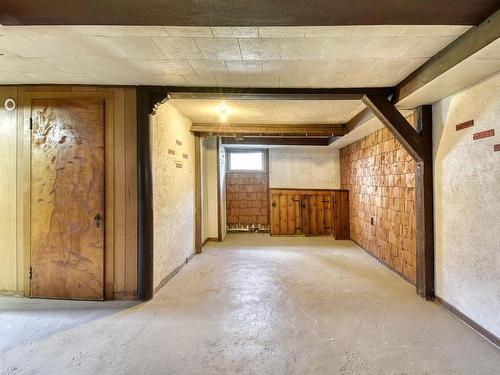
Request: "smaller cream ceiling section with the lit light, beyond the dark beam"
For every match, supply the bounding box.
[168,99,365,124]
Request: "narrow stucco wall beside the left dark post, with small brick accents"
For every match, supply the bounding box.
[151,103,194,288]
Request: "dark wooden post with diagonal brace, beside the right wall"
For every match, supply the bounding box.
[363,96,434,299]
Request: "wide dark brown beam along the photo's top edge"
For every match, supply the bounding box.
[0,0,498,26]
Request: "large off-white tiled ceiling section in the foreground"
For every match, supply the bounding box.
[0,26,469,87]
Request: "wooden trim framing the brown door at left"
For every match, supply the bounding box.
[22,89,115,300]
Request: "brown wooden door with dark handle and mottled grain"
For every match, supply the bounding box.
[31,99,104,300]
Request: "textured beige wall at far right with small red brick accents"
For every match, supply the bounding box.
[433,75,500,336]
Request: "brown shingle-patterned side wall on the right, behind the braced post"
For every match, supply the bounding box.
[340,128,416,283]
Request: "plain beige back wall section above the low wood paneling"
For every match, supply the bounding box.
[269,147,340,189]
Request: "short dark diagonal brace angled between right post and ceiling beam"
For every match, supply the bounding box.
[363,96,425,161]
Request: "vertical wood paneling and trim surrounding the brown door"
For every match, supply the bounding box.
[0,85,137,299]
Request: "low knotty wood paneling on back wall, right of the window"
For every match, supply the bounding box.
[269,189,349,238]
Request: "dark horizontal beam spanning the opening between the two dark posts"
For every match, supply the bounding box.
[166,86,393,100]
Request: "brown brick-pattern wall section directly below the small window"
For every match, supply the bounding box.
[226,172,269,225]
